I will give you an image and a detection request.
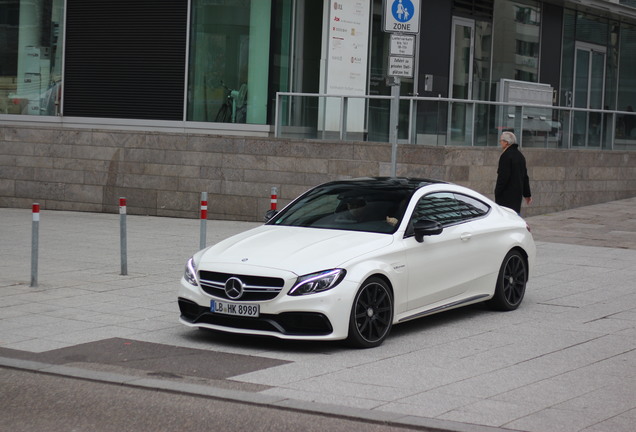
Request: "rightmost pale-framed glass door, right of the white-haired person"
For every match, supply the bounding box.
[572,42,606,147]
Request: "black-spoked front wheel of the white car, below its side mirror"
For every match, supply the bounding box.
[347,277,393,348]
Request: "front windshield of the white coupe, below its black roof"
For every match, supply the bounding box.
[269,181,415,234]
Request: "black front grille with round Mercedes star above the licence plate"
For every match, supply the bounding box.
[199,271,285,301]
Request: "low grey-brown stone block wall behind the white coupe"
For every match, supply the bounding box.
[0,125,636,221]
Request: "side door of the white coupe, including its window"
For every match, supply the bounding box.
[404,192,490,310]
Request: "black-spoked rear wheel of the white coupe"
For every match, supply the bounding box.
[489,249,528,311]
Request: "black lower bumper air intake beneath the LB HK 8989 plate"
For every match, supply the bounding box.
[179,298,333,336]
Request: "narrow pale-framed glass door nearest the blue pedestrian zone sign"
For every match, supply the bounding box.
[448,18,475,145]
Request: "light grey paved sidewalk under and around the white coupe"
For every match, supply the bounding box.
[0,198,636,432]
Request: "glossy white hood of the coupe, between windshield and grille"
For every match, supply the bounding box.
[198,225,393,275]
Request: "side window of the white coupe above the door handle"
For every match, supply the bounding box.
[411,192,490,226]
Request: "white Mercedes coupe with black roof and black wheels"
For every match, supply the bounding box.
[178,178,536,348]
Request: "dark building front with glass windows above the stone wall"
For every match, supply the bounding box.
[0,0,636,148]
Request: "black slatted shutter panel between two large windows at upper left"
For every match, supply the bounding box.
[63,0,187,120]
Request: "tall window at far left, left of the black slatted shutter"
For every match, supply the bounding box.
[0,0,64,116]
